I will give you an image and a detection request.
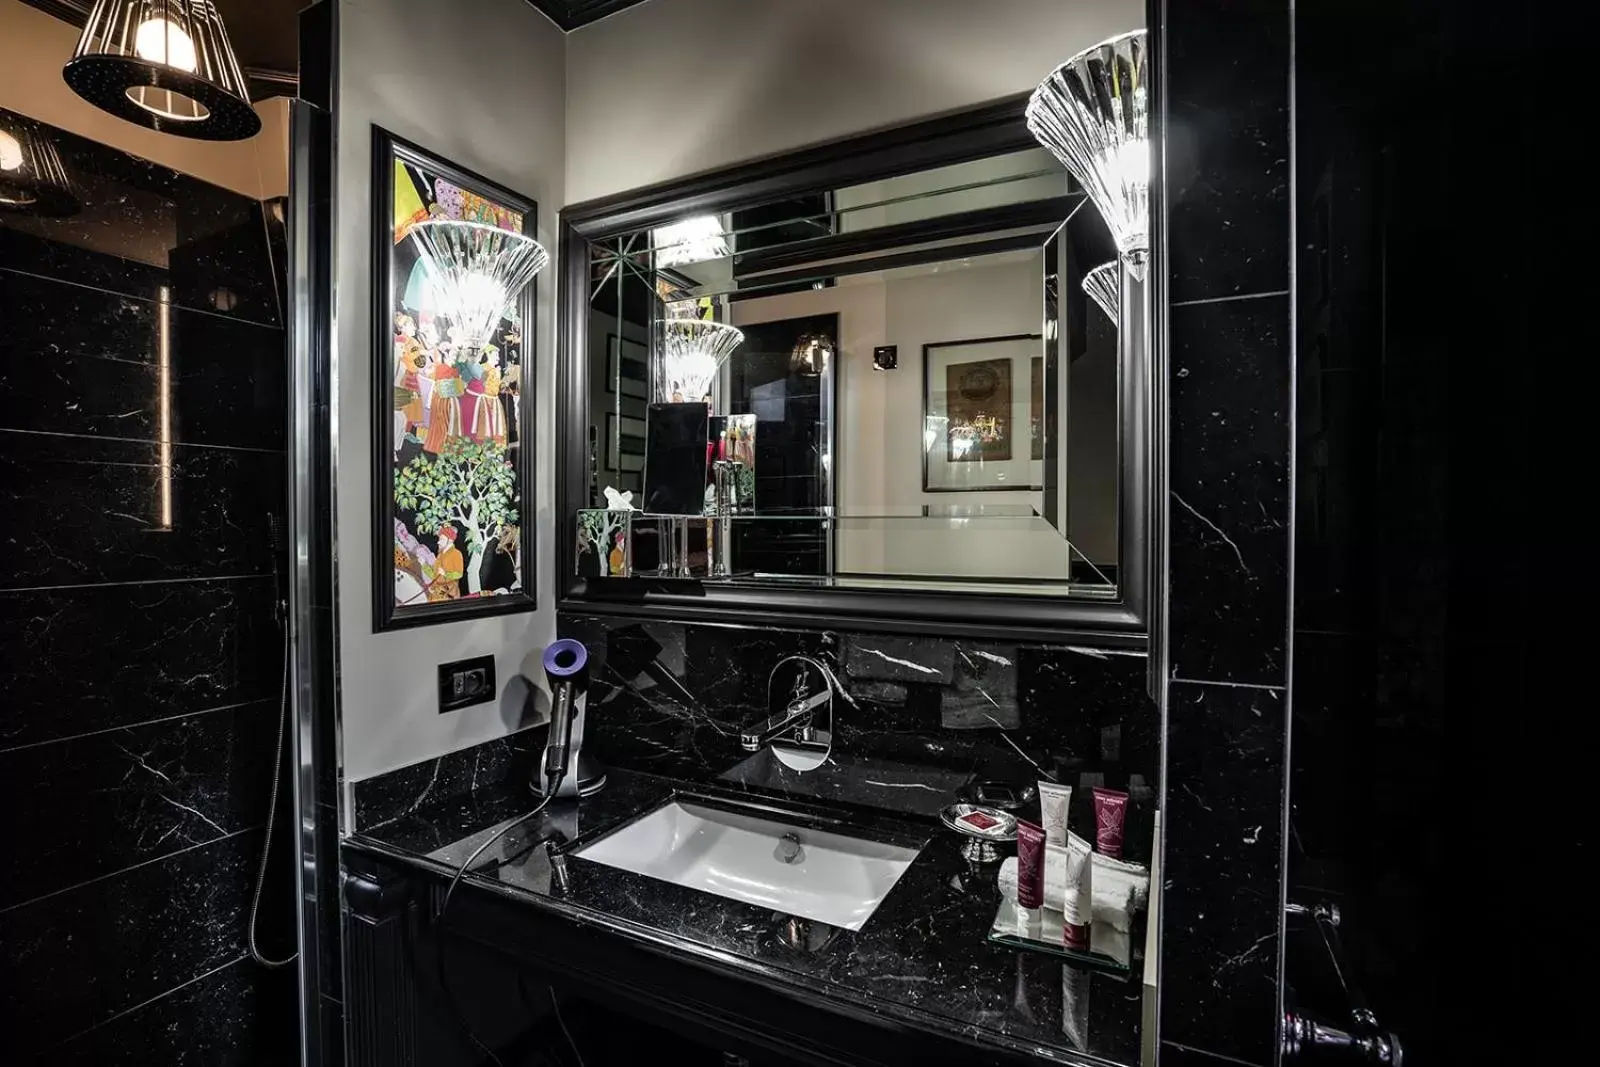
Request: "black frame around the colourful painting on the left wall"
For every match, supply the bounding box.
[370,123,539,633]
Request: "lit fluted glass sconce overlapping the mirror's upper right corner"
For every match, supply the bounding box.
[1027,30,1150,280]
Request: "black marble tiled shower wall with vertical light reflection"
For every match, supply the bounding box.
[0,112,296,1067]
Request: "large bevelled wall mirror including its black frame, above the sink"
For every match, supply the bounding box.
[562,93,1150,640]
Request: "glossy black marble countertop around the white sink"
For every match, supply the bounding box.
[350,769,1146,1064]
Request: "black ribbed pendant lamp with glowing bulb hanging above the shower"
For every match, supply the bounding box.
[61,0,261,141]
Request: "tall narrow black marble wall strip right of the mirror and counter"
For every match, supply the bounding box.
[1157,0,1293,1065]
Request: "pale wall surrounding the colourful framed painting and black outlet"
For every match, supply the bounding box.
[334,0,565,781]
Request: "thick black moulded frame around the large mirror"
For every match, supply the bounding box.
[555,94,1163,649]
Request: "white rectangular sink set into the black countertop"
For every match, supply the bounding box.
[574,800,920,929]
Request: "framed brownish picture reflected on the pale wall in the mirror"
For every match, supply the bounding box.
[922,334,1046,493]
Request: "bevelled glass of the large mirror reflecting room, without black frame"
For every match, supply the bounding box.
[579,149,1122,597]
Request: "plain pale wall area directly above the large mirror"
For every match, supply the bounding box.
[566,0,1144,203]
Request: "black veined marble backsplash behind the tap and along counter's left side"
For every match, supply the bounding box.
[354,616,1160,859]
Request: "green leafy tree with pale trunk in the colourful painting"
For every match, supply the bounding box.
[395,437,517,593]
